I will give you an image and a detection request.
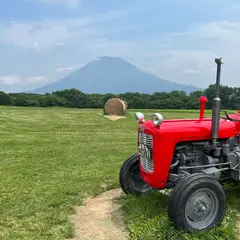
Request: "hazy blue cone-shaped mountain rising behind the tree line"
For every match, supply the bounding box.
[29,56,200,94]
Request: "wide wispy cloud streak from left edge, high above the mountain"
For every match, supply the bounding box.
[0,7,131,50]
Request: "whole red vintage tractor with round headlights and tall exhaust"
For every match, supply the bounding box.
[119,58,240,232]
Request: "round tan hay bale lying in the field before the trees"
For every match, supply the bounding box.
[104,98,127,115]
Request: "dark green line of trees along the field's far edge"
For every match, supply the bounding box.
[0,84,240,109]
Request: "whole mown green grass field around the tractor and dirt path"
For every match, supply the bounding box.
[0,107,240,240]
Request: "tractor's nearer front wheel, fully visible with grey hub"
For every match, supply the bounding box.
[168,174,227,232]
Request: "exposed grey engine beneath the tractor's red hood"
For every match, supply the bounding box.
[169,136,240,182]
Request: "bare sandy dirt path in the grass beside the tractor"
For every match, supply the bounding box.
[69,189,128,240]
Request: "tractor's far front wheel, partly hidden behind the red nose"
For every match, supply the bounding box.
[119,154,152,196]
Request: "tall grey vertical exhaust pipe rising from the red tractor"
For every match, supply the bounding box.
[212,58,223,148]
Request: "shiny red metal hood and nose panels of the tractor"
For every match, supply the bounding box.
[138,114,240,189]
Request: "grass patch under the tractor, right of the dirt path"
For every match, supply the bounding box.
[120,185,240,240]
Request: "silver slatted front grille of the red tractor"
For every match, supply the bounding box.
[138,132,153,172]
